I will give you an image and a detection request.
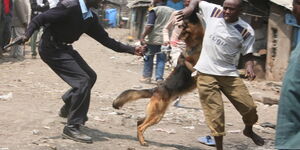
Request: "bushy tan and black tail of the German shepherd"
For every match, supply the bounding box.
[113,89,154,109]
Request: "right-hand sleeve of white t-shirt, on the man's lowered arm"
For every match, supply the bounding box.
[241,28,255,55]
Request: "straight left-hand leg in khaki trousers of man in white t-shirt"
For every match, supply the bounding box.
[197,73,225,150]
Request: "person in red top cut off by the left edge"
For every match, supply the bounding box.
[0,0,13,58]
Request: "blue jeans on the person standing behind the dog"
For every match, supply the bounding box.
[143,45,166,80]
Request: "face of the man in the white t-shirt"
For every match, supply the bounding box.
[223,0,241,23]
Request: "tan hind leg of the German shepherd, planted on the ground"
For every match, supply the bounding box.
[137,96,169,146]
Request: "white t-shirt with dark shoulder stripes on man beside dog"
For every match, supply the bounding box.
[194,1,255,76]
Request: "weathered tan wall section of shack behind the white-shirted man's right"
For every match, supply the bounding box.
[266,4,292,81]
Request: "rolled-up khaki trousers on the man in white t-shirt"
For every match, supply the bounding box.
[197,73,258,136]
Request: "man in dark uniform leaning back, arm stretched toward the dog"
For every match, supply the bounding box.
[22,0,144,143]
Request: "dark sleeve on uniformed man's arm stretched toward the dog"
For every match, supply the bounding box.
[86,14,135,54]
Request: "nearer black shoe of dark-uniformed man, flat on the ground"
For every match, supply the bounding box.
[62,125,93,143]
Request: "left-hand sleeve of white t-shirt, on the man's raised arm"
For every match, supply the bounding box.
[199,1,223,21]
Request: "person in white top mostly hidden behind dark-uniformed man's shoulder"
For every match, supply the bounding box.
[30,0,49,58]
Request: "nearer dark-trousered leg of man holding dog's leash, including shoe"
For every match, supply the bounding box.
[40,41,96,143]
